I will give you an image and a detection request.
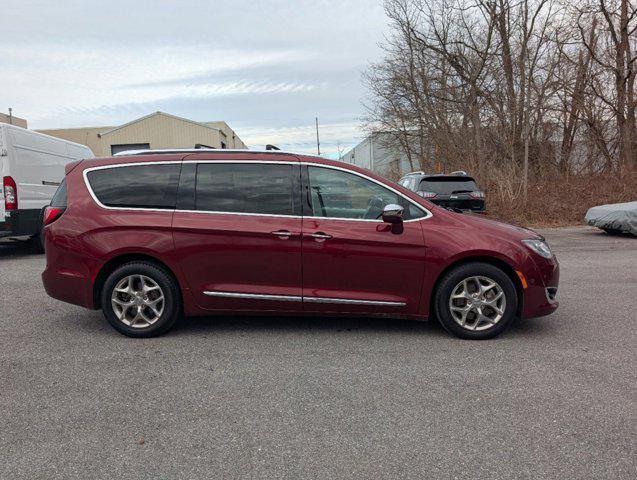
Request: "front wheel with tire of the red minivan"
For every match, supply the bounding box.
[434,262,518,340]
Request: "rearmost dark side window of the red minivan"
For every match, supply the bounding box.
[87,164,181,209]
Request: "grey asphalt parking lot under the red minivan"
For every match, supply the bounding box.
[0,227,637,479]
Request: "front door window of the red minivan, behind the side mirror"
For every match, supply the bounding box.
[308,167,426,220]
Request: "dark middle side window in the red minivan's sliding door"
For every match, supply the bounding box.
[195,162,294,215]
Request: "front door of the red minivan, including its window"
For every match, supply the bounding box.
[302,164,429,314]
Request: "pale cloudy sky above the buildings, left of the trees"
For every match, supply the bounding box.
[0,0,386,154]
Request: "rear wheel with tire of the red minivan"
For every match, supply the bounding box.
[101,261,181,338]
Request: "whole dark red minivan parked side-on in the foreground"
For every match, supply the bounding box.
[42,150,559,339]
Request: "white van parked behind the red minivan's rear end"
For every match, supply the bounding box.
[0,123,94,249]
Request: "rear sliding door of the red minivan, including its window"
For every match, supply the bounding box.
[173,155,302,311]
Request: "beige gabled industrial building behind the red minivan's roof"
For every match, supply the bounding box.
[38,112,247,157]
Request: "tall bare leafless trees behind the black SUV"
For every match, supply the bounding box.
[365,0,637,198]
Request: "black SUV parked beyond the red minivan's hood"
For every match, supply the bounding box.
[398,172,486,213]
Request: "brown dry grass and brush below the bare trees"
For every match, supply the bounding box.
[487,175,637,227]
